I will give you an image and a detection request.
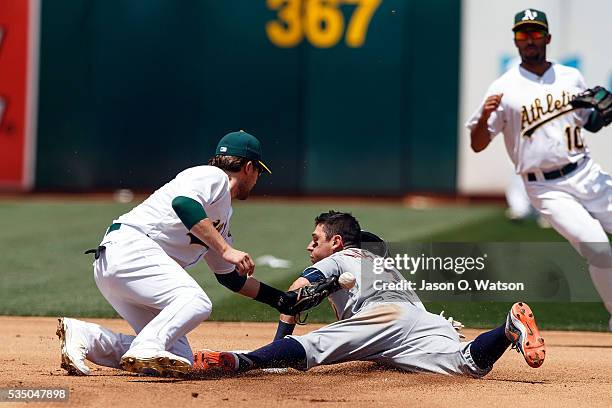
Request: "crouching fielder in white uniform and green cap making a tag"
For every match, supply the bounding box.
[57,131,304,375]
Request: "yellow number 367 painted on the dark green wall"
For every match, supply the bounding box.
[266,0,382,48]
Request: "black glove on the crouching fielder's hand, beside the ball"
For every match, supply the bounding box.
[277,276,340,316]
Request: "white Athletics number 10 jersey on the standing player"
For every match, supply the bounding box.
[466,63,590,174]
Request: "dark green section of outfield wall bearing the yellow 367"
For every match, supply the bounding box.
[36,0,460,194]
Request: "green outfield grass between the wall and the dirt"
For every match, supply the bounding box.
[0,200,608,331]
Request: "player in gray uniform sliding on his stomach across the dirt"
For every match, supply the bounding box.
[194,211,546,377]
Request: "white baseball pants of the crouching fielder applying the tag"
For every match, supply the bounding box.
[76,224,212,368]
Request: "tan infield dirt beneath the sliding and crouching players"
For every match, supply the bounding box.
[0,317,612,408]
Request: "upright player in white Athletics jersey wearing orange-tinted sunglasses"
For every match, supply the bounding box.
[466,9,612,330]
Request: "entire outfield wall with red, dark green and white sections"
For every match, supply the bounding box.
[0,0,612,195]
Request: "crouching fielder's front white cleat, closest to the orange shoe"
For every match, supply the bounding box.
[119,349,191,377]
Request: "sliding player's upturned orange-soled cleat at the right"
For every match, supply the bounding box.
[505,302,546,368]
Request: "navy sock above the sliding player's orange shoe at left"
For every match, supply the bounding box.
[238,337,306,371]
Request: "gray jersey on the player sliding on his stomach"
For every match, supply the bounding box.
[312,248,425,320]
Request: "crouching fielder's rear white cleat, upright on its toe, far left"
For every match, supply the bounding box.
[55,317,90,375]
